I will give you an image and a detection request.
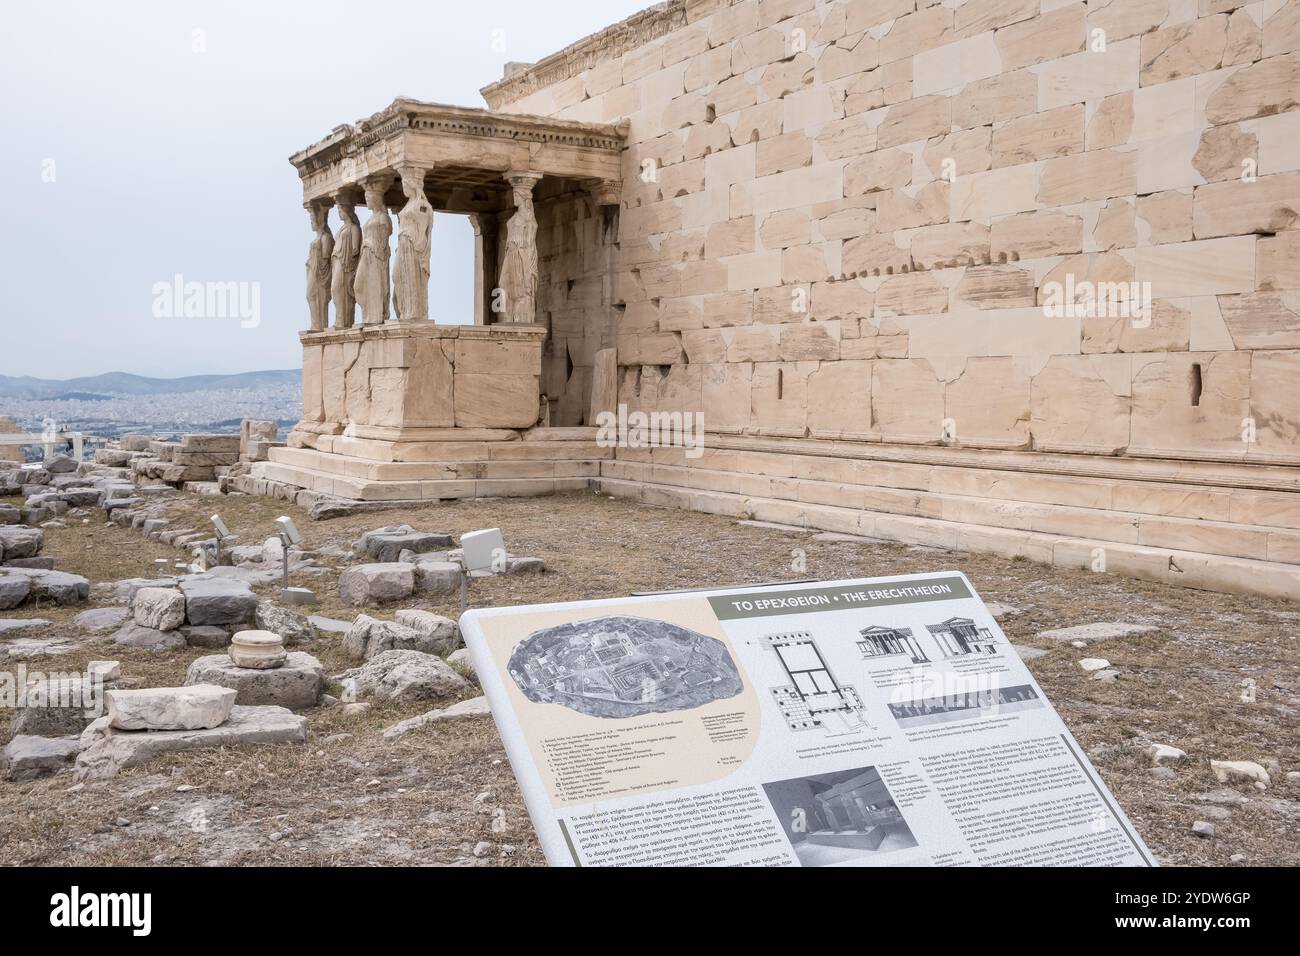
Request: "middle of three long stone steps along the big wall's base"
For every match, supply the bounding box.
[602,462,1300,564]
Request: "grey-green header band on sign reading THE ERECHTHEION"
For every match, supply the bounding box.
[709,575,971,620]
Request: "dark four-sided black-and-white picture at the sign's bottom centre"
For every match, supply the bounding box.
[763,767,917,866]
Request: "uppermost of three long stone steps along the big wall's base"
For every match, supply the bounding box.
[618,447,1300,531]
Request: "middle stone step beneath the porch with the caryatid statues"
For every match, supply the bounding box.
[270,447,599,481]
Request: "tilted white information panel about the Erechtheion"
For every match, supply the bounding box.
[460,571,1154,866]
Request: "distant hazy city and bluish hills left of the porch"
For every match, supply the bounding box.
[0,369,302,447]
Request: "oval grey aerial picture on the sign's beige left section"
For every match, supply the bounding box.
[510,615,742,718]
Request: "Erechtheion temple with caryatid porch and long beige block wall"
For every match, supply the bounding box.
[246,0,1300,597]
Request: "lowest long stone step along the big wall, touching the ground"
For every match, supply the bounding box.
[597,477,1300,600]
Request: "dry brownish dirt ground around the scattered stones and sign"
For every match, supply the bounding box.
[0,493,1300,866]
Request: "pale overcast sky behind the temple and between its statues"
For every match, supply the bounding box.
[0,0,649,378]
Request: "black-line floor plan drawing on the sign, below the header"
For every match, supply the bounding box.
[762,631,868,736]
